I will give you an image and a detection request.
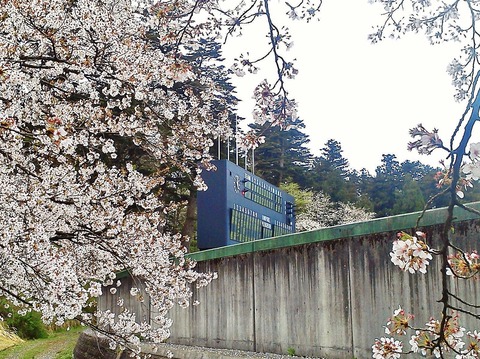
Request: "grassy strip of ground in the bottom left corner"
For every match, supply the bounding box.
[0,327,85,359]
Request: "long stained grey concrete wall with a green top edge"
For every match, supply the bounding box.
[99,203,480,359]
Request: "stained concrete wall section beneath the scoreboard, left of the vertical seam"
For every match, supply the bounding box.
[169,255,256,351]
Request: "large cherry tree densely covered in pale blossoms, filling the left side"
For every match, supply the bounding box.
[0,0,321,354]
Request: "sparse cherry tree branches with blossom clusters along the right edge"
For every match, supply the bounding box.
[370,0,480,359]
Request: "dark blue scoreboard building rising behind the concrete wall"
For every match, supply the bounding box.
[197,160,295,249]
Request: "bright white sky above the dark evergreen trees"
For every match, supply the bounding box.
[225,0,465,174]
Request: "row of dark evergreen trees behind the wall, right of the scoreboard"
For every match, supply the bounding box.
[251,119,480,217]
